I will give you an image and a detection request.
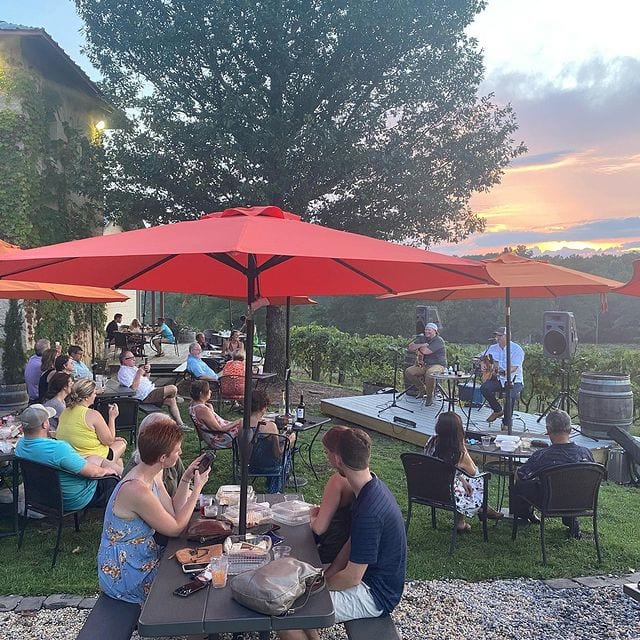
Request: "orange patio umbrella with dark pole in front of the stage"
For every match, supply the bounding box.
[379,252,621,433]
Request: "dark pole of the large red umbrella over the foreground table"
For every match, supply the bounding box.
[238,254,259,535]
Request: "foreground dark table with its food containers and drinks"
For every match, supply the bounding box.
[138,485,334,640]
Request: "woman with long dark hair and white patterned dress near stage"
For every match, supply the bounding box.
[424,411,504,532]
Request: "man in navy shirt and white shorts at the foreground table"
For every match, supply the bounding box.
[279,429,407,640]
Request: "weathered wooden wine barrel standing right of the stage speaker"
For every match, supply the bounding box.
[578,372,633,439]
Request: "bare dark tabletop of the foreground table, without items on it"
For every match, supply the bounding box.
[138,494,334,639]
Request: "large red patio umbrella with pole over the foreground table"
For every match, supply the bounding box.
[0,206,491,529]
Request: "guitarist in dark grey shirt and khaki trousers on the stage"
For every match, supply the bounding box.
[404,322,447,407]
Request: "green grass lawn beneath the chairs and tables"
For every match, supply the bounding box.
[0,392,640,595]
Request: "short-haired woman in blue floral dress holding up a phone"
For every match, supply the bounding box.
[98,414,209,604]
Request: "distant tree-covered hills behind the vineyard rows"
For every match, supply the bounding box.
[165,253,640,344]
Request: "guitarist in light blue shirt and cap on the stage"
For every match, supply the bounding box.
[480,327,524,422]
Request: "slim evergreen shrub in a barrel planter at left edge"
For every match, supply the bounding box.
[0,300,29,412]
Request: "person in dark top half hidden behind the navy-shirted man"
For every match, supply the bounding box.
[310,426,355,564]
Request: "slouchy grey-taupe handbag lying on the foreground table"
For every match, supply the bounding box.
[230,557,325,616]
